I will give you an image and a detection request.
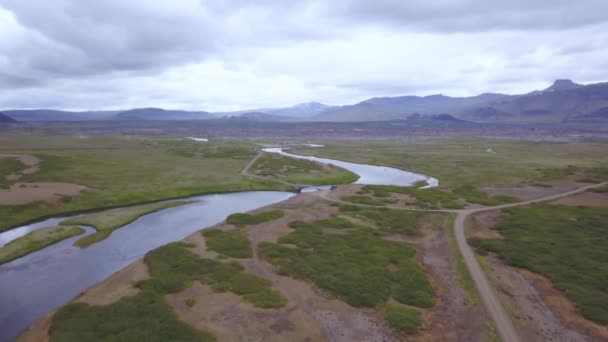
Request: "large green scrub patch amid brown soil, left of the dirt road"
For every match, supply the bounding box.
[260,221,434,307]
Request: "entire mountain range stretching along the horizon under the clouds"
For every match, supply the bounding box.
[4,80,608,123]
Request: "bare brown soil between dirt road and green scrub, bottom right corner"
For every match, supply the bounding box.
[487,255,608,342]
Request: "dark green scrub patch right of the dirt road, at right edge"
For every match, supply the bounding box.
[470,205,608,324]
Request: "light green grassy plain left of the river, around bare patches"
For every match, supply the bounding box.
[0,134,291,231]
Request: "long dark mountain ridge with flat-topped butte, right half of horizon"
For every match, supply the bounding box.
[312,80,608,123]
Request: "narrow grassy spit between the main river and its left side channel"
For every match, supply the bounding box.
[60,201,190,247]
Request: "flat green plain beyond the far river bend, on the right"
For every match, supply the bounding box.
[293,137,608,189]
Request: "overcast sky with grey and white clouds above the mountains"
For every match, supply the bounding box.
[0,0,608,111]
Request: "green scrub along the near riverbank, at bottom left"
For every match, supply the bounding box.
[50,242,286,342]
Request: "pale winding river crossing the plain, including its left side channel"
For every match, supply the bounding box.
[0,148,437,341]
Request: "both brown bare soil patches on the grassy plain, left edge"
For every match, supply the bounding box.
[0,154,87,205]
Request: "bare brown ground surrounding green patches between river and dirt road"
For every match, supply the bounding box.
[22,186,494,341]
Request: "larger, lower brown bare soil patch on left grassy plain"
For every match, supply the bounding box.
[0,182,87,205]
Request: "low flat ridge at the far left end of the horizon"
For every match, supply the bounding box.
[4,109,117,121]
